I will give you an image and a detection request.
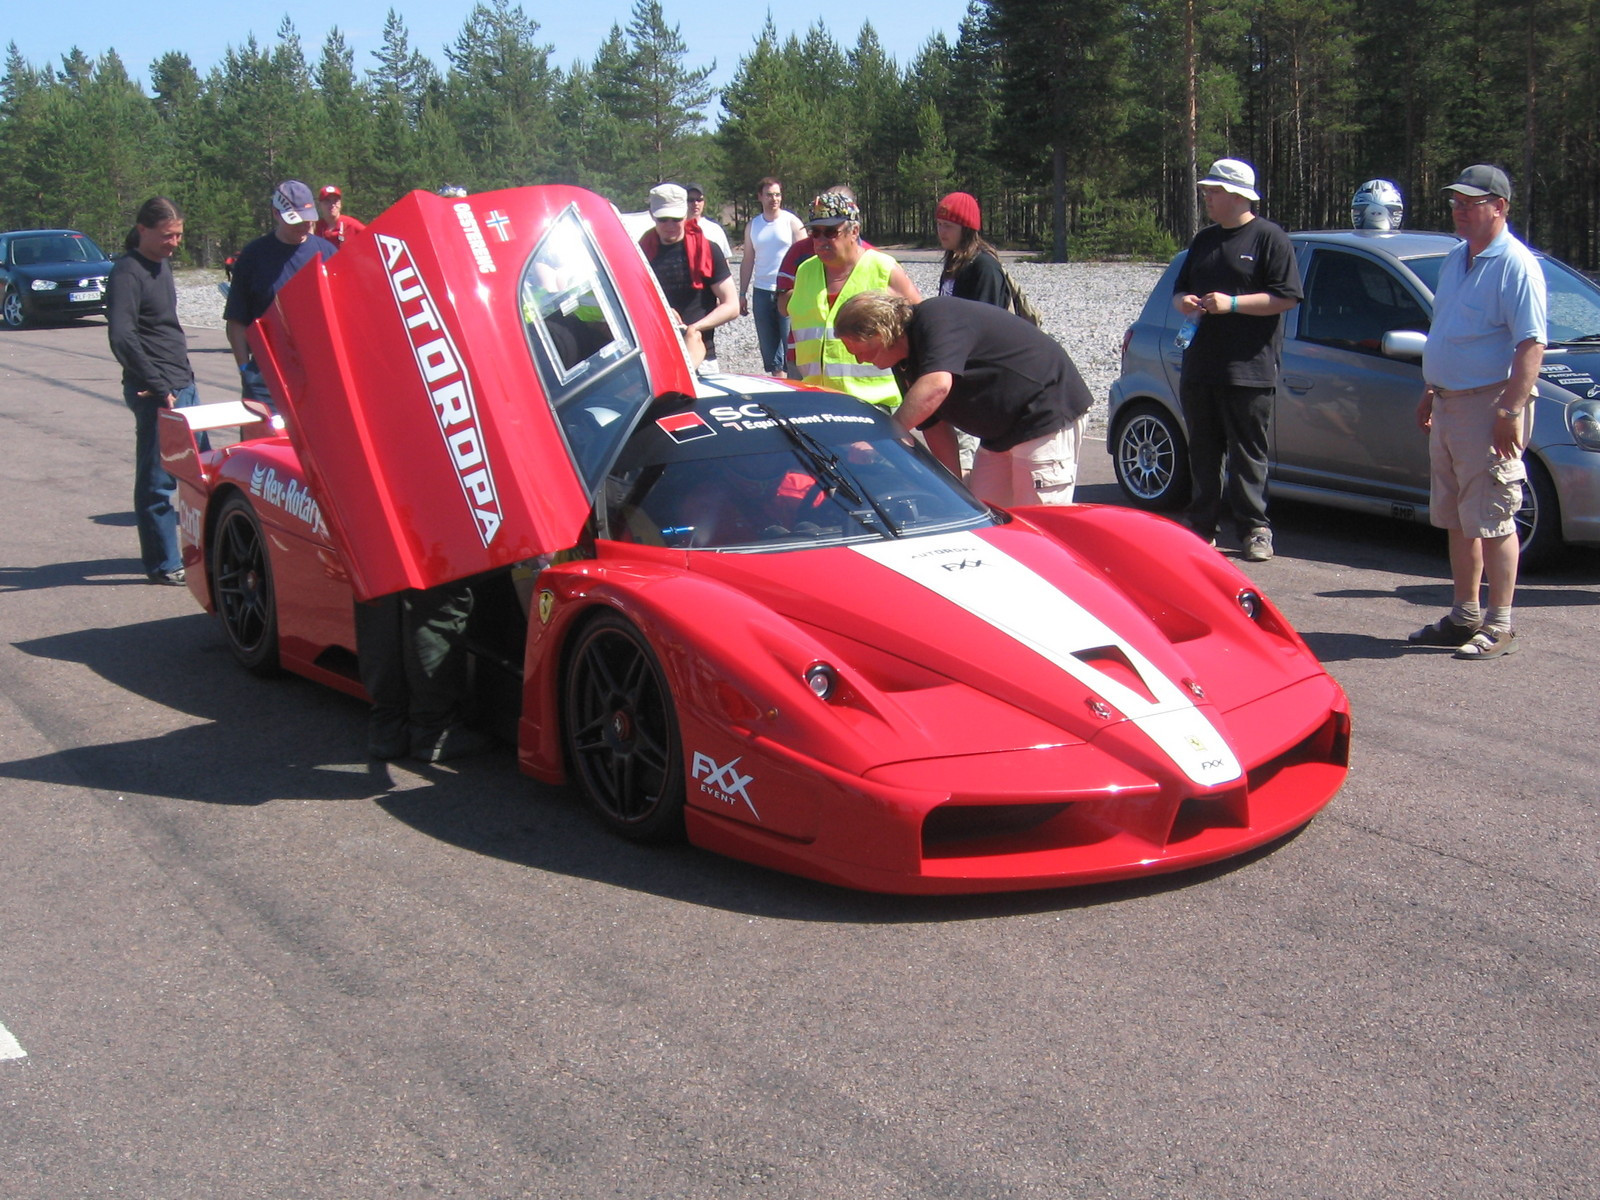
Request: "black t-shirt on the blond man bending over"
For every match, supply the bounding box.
[894,296,1093,451]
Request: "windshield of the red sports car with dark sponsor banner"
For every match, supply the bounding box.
[605,392,995,552]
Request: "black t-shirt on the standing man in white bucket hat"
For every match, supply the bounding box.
[1173,216,1306,387]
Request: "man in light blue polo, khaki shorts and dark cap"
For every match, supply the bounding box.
[1410,163,1547,659]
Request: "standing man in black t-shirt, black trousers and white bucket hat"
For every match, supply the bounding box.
[1173,158,1304,563]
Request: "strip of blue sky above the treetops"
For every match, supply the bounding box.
[9,0,966,118]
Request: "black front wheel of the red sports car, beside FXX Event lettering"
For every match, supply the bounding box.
[562,613,683,842]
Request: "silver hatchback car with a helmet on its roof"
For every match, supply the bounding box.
[1106,230,1600,568]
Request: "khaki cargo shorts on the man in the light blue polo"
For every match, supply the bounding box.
[1427,384,1528,538]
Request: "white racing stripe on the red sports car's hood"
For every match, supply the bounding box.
[851,533,1243,787]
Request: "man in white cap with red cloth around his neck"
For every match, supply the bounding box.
[638,184,739,374]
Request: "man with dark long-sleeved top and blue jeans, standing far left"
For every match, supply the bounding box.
[106,197,198,584]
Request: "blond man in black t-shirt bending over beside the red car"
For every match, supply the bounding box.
[834,291,1093,507]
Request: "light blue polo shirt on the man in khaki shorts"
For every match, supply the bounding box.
[1422,229,1549,392]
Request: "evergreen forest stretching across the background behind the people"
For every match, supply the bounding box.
[0,0,1600,269]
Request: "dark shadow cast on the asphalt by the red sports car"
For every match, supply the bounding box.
[0,613,1293,923]
